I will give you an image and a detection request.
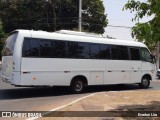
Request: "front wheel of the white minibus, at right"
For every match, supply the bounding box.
[139,77,150,89]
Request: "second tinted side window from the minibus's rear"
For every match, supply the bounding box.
[39,40,53,57]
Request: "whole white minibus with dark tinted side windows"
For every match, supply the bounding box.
[1,30,156,93]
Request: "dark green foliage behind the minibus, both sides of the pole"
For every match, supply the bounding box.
[0,0,108,33]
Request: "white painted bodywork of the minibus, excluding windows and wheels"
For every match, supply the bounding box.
[2,30,154,86]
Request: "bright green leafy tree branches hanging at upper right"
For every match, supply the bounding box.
[124,0,160,49]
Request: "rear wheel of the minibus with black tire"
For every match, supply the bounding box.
[70,77,85,94]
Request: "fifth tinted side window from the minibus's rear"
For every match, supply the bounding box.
[78,43,89,59]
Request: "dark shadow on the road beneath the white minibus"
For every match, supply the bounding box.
[0,85,148,100]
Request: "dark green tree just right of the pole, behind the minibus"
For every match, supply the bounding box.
[82,0,108,34]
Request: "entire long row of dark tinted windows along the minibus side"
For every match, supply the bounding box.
[23,38,132,60]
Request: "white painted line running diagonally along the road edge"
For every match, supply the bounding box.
[26,93,96,120]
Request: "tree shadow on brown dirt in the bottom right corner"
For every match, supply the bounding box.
[110,101,160,120]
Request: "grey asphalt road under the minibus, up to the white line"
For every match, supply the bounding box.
[0,75,160,111]
